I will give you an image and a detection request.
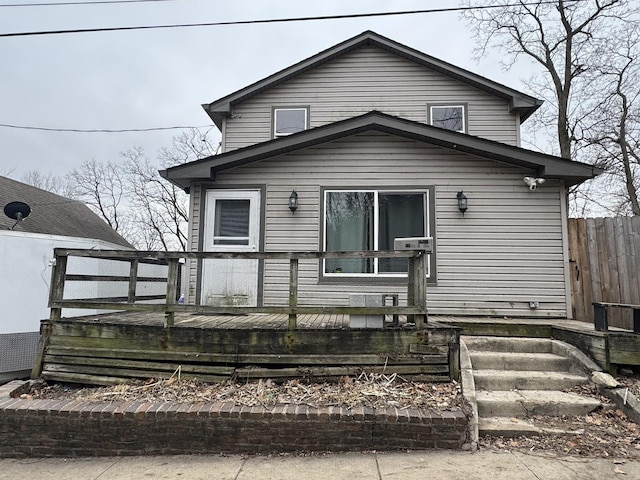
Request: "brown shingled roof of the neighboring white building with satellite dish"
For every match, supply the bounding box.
[0,176,133,248]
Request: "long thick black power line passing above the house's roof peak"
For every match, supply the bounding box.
[0,0,583,38]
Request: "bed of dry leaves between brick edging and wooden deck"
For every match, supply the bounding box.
[23,373,469,412]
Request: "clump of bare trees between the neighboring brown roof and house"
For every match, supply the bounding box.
[24,129,215,250]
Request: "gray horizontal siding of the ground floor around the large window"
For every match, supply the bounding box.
[191,133,567,317]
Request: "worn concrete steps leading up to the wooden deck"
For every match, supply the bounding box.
[461,336,600,436]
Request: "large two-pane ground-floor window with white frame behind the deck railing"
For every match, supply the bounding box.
[324,190,430,276]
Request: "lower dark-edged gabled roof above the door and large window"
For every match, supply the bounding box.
[160,111,602,189]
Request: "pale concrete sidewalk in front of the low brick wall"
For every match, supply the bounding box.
[0,450,640,480]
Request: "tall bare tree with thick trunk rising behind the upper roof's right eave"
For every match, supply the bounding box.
[464,0,630,158]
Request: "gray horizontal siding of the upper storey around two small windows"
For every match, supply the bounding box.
[224,47,519,152]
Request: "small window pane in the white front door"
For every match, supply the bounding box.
[213,200,251,245]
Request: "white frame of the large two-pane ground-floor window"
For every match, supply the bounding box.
[321,188,435,279]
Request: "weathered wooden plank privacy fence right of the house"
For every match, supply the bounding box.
[569,217,640,330]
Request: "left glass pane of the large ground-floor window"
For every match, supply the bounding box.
[325,192,374,273]
